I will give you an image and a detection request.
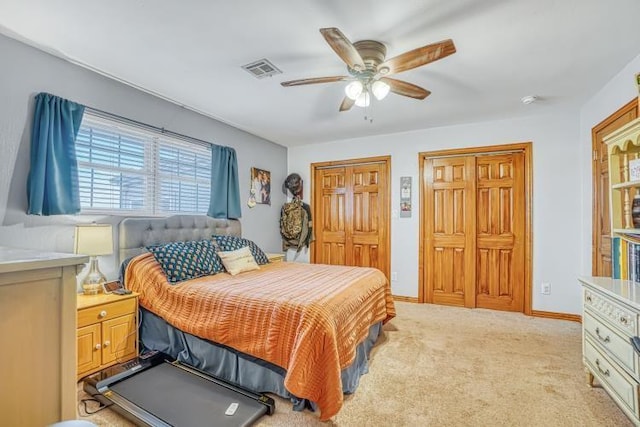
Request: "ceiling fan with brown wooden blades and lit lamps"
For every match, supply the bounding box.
[280,28,456,111]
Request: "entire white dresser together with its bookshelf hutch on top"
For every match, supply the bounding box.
[580,119,640,425]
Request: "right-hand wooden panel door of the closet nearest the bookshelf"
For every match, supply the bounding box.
[476,153,525,312]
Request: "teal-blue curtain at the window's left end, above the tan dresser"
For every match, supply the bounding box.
[27,93,84,215]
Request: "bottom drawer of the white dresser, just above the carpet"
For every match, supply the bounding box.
[584,337,638,417]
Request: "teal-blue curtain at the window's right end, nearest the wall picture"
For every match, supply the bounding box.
[207,145,242,219]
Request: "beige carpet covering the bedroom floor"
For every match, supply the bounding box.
[78,302,632,426]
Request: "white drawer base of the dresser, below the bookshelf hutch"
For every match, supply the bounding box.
[579,277,640,425]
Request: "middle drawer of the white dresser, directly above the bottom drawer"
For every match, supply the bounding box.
[582,311,640,379]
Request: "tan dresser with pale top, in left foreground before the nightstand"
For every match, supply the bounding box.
[0,247,89,427]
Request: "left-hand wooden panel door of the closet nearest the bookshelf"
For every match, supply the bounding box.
[423,156,476,307]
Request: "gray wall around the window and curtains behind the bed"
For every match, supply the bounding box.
[0,35,287,277]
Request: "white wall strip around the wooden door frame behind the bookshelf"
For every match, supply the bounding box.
[580,55,640,275]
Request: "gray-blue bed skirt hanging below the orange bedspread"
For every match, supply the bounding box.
[140,308,382,411]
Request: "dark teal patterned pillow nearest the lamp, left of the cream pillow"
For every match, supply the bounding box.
[147,240,224,283]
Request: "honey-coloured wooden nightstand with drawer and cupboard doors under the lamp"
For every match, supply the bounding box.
[77,292,138,379]
